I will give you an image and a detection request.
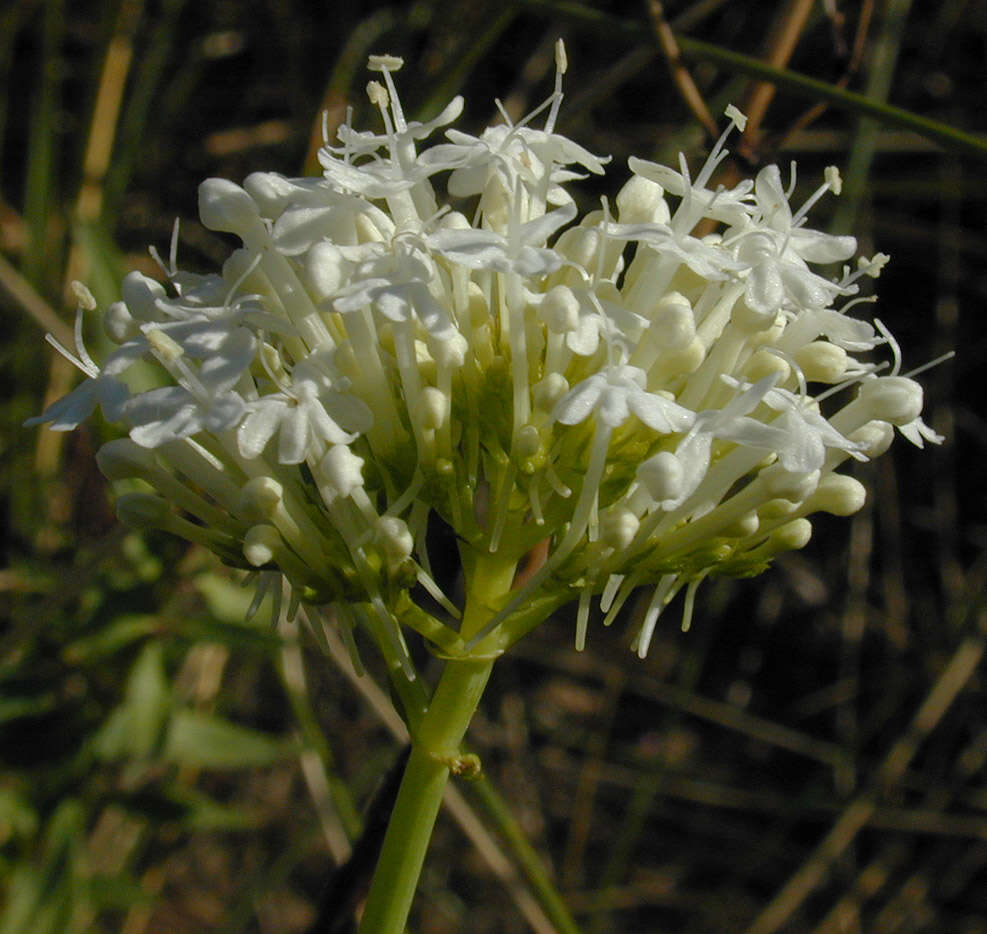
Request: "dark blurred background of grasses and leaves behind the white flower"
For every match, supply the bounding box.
[0,0,987,934]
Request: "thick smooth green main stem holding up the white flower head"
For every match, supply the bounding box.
[360,552,516,934]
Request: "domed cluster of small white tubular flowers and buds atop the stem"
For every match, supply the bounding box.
[35,44,941,655]
